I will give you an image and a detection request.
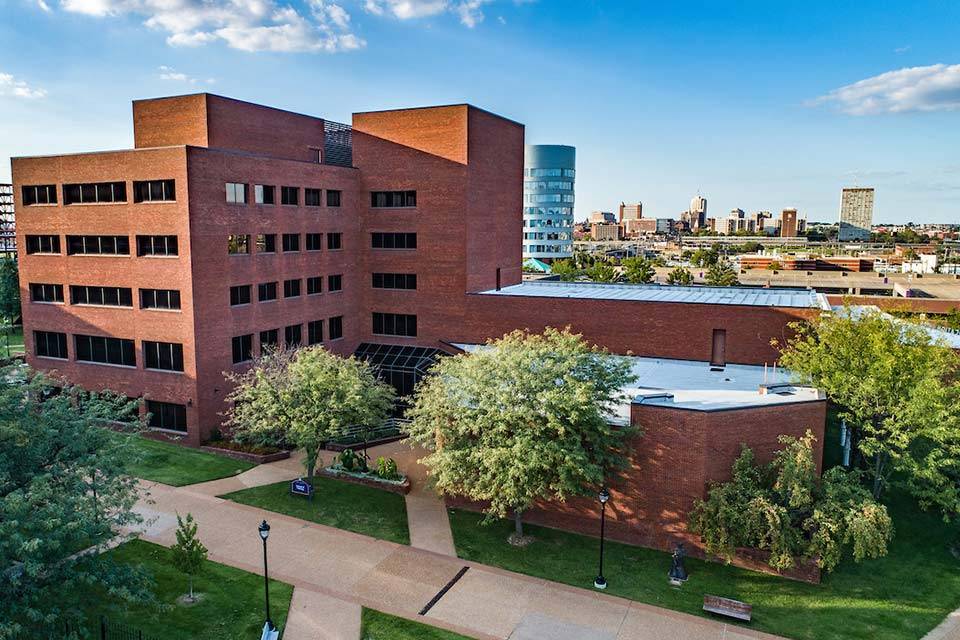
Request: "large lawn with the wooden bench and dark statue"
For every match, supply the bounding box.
[450,495,960,640]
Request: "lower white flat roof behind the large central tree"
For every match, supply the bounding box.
[453,344,823,424]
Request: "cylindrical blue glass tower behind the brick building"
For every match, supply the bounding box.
[523,144,577,262]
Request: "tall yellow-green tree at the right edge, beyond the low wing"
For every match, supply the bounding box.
[781,307,960,516]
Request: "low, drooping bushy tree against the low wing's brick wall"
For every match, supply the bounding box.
[690,431,893,572]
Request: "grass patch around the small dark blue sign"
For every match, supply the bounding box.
[220,476,410,544]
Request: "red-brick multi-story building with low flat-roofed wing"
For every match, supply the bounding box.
[13,94,826,556]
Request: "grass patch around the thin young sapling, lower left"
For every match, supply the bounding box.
[91,540,293,640]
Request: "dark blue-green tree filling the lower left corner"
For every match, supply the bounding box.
[0,368,149,638]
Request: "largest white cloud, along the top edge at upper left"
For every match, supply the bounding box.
[61,0,366,53]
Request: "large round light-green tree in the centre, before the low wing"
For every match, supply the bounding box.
[407,328,634,543]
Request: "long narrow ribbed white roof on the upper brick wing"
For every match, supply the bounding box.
[480,280,830,310]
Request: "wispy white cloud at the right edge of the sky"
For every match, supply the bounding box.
[809,64,960,116]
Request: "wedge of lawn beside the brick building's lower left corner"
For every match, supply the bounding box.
[118,434,255,487]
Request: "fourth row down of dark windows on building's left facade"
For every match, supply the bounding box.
[33,331,183,372]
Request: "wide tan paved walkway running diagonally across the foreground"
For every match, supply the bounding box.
[131,482,773,640]
